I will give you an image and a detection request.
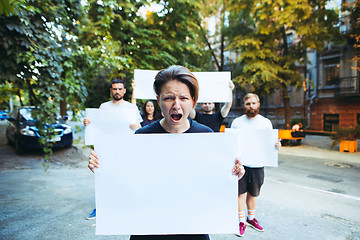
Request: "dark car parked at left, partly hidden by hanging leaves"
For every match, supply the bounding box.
[6,107,73,153]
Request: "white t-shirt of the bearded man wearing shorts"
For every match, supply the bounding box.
[231,114,273,168]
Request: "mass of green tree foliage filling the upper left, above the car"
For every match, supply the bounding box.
[0,0,214,160]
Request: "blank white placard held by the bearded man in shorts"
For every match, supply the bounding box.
[225,128,279,167]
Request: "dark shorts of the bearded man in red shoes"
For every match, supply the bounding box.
[238,166,264,197]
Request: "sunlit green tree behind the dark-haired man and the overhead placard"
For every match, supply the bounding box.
[79,0,208,107]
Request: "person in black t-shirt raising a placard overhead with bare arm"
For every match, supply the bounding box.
[189,81,235,132]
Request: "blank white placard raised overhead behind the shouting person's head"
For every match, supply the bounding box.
[134,69,231,102]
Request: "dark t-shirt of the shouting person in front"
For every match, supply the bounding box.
[134,119,213,240]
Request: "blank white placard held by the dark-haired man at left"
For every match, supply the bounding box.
[85,108,136,145]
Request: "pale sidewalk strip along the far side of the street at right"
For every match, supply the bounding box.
[279,135,360,165]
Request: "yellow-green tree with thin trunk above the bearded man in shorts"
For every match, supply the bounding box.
[229,0,341,128]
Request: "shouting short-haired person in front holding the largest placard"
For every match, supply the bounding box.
[88,66,244,240]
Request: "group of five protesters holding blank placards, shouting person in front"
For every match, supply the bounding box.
[84,65,280,240]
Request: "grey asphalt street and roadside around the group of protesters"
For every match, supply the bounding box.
[0,122,360,240]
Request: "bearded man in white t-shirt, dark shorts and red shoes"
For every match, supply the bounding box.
[231,93,280,236]
